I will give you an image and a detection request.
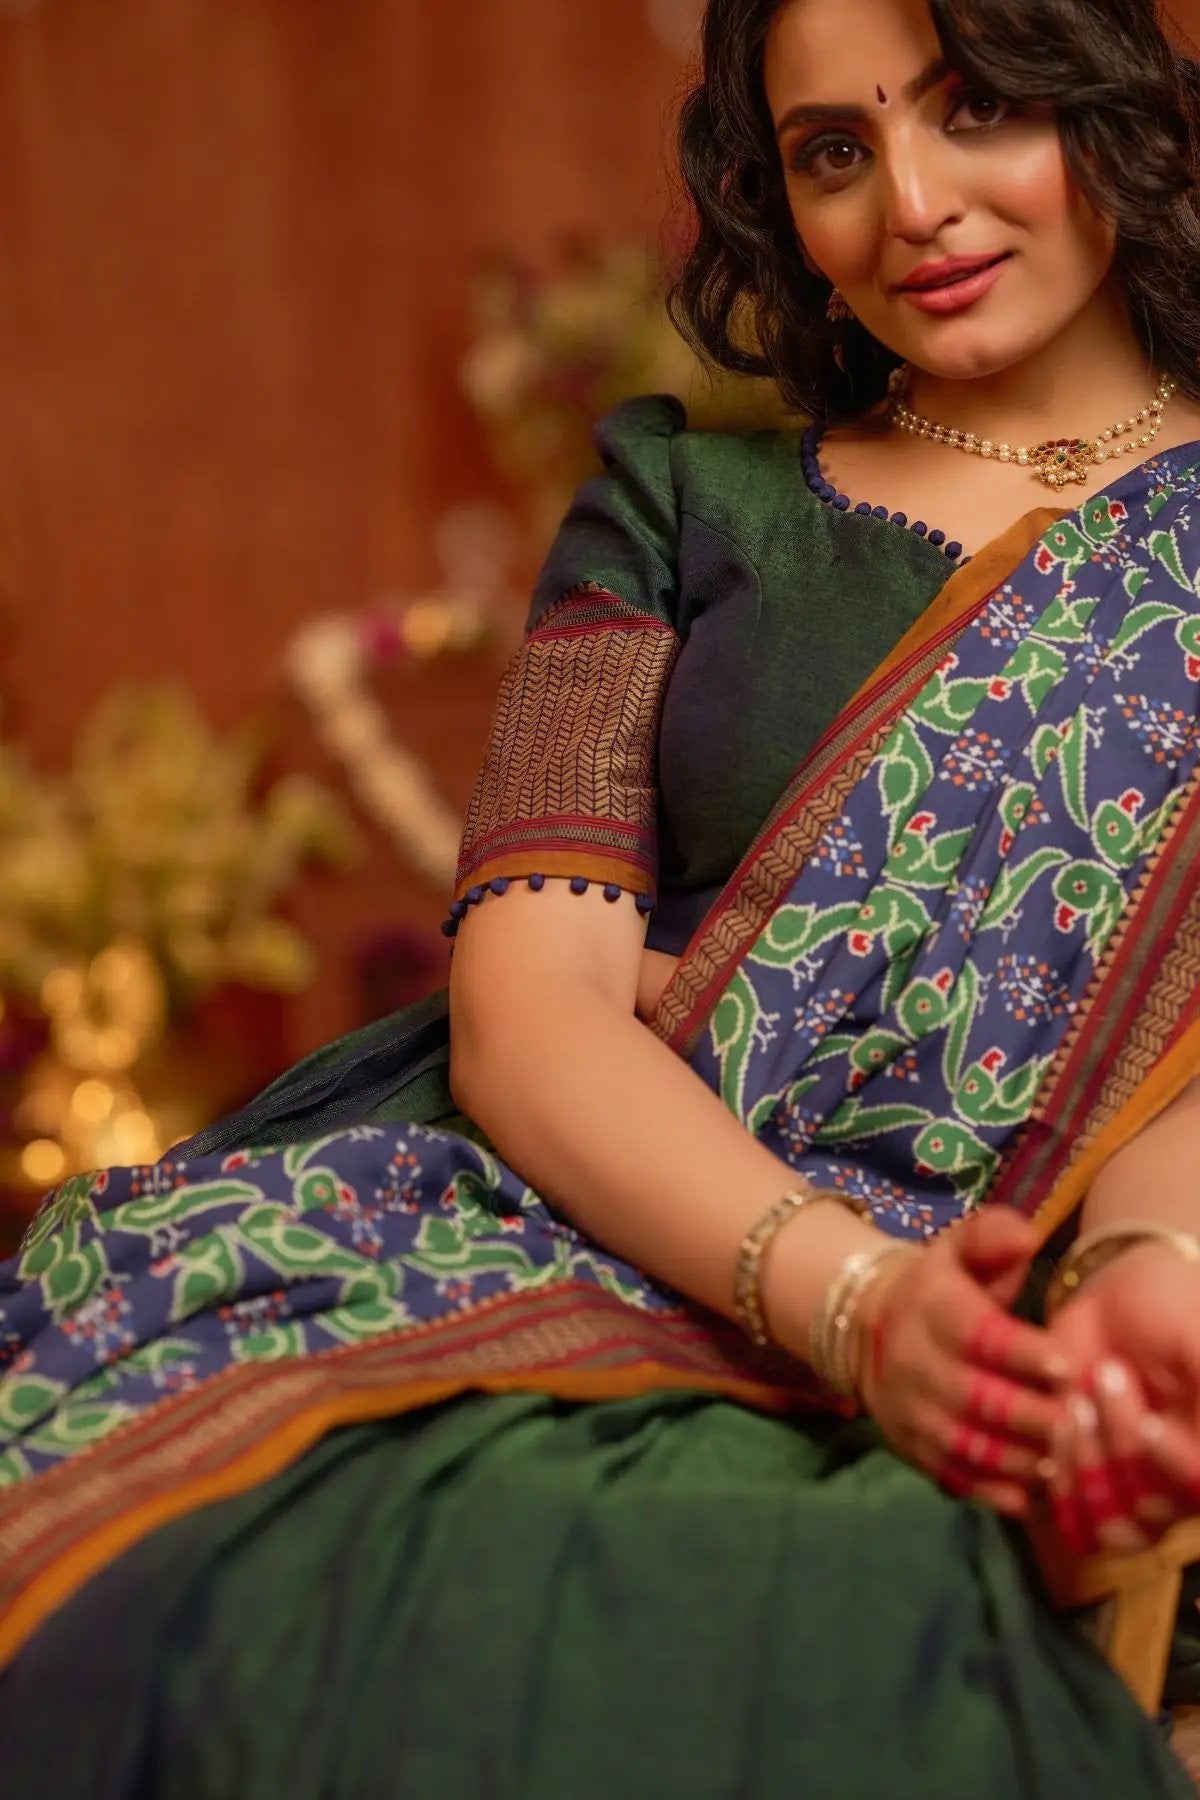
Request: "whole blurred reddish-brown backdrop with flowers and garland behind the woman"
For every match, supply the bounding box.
[0,0,1200,1231]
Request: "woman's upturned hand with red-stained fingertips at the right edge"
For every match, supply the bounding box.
[1051,1242,1200,1555]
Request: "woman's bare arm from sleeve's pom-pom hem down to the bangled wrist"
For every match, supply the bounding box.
[450,882,880,1357]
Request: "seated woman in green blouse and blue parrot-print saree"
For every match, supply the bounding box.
[0,0,1200,1800]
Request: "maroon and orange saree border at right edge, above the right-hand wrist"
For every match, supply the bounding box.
[990,752,1200,1237]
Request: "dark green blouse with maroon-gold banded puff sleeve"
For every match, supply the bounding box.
[457,396,954,952]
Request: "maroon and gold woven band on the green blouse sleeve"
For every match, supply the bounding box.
[453,581,680,904]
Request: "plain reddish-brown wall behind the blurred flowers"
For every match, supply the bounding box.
[0,0,1200,1055]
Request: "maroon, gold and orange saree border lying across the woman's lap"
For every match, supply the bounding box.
[0,1282,816,1665]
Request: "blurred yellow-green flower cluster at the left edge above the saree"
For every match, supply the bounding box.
[0,686,353,1044]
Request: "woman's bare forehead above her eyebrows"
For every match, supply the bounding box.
[763,0,941,117]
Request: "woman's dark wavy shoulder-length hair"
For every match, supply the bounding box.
[669,0,1200,423]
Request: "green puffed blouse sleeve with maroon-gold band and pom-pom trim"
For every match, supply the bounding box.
[448,398,685,931]
